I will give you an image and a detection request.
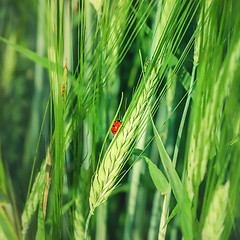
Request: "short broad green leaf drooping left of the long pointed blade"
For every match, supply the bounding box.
[144,156,168,195]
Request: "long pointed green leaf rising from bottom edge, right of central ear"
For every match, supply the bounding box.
[151,118,193,239]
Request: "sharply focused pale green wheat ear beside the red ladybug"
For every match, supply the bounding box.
[89,75,154,214]
